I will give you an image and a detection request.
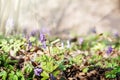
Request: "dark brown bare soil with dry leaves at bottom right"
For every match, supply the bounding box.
[63,66,120,80]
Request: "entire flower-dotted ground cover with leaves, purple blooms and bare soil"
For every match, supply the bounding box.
[0,32,120,80]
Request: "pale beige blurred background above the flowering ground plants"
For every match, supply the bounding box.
[0,0,120,36]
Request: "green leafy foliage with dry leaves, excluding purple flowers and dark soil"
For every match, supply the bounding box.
[0,34,120,80]
